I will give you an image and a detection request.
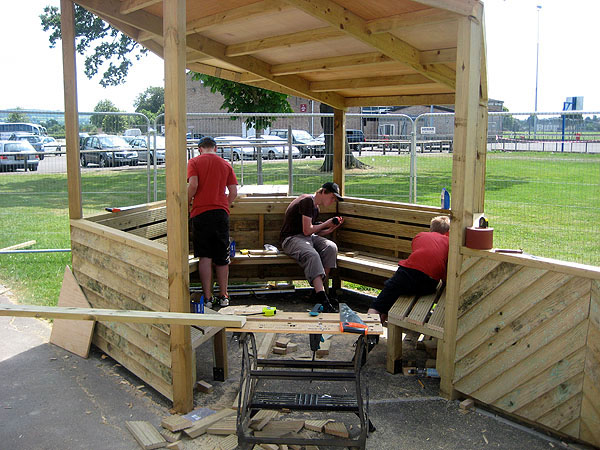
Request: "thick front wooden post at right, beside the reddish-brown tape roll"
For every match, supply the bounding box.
[438,5,483,398]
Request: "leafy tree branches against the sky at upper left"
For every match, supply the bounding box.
[40,5,148,87]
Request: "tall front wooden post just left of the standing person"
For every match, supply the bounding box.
[163,0,194,413]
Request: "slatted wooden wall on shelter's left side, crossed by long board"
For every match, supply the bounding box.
[71,220,173,399]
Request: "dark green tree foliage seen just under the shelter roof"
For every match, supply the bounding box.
[192,73,293,136]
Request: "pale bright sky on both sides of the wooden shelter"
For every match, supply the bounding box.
[0,0,600,112]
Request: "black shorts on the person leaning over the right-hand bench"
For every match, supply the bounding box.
[371,266,439,314]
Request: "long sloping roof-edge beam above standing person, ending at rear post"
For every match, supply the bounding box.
[187,34,345,109]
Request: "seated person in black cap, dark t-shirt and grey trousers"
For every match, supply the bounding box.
[280,182,344,312]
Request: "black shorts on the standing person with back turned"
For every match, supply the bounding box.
[192,209,229,266]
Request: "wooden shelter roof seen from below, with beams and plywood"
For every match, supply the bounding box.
[76,0,483,109]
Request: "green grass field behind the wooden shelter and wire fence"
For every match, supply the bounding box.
[0,153,600,305]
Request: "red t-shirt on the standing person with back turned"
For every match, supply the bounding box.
[188,153,237,217]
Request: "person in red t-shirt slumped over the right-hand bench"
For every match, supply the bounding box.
[368,216,450,323]
